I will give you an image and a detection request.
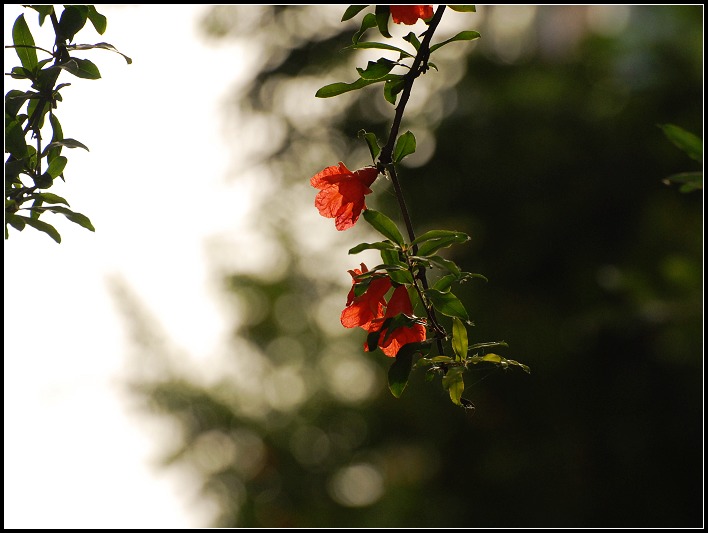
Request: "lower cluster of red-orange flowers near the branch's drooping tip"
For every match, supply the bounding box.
[341,263,426,357]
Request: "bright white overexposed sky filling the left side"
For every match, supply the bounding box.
[4,4,248,529]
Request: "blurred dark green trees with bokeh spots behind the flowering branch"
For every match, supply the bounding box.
[116,6,703,527]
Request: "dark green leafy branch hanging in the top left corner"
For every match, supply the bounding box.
[5,5,132,243]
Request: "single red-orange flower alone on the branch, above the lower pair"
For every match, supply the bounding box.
[310,162,379,231]
